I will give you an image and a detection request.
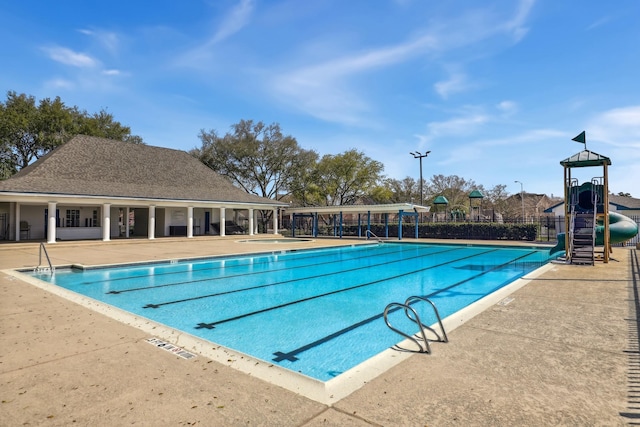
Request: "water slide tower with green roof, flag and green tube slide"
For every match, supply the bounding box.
[550,145,638,265]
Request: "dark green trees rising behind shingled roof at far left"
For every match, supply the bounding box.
[0,91,143,179]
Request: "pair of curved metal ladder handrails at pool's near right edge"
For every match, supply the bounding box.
[384,296,449,354]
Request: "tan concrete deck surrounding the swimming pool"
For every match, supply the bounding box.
[0,235,640,426]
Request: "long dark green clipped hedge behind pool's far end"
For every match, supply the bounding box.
[318,222,538,241]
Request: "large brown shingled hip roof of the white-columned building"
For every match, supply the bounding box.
[0,135,281,206]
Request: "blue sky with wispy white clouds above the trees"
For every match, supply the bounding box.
[0,0,640,197]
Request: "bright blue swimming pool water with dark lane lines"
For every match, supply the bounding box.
[27,243,549,381]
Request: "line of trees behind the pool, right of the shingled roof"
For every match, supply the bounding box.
[190,120,524,215]
